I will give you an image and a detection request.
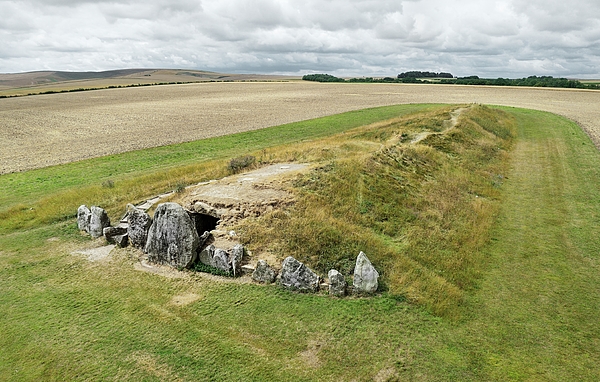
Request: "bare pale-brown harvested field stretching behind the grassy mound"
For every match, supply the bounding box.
[0,82,600,174]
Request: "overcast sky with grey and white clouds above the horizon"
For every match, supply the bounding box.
[0,0,600,78]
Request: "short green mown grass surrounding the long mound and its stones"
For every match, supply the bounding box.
[0,105,600,381]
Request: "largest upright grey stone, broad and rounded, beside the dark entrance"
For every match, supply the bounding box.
[145,203,198,268]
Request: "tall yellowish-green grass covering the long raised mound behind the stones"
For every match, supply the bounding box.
[238,106,515,316]
